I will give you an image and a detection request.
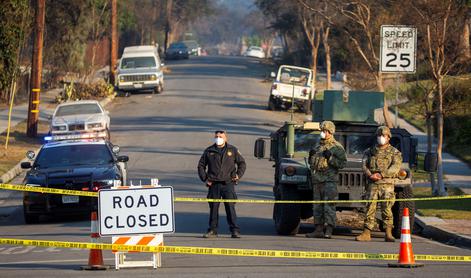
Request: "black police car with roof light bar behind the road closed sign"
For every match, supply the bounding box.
[21,133,129,223]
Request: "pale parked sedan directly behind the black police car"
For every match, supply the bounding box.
[50,100,110,138]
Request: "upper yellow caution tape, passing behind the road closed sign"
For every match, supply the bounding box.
[0,183,471,204]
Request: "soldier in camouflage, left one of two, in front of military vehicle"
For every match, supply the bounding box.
[306,121,347,238]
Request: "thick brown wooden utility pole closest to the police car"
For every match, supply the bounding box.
[26,0,46,137]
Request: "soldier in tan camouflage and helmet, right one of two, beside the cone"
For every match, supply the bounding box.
[355,126,402,242]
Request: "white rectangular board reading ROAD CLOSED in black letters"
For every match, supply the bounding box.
[98,186,175,236]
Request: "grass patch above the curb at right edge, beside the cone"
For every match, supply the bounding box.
[413,187,471,220]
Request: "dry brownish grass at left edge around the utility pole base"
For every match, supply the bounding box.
[0,121,48,175]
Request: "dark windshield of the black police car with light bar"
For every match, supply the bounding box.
[35,145,113,168]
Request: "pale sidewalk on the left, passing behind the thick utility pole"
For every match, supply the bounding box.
[0,89,60,133]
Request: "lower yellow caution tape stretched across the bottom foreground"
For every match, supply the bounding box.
[0,238,471,262]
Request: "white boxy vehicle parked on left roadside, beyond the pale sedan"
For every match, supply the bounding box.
[117,45,164,94]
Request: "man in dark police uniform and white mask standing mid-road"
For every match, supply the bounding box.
[198,130,246,238]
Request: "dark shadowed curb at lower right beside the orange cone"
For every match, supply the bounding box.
[415,214,471,249]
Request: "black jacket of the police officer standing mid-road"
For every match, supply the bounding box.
[198,143,246,182]
